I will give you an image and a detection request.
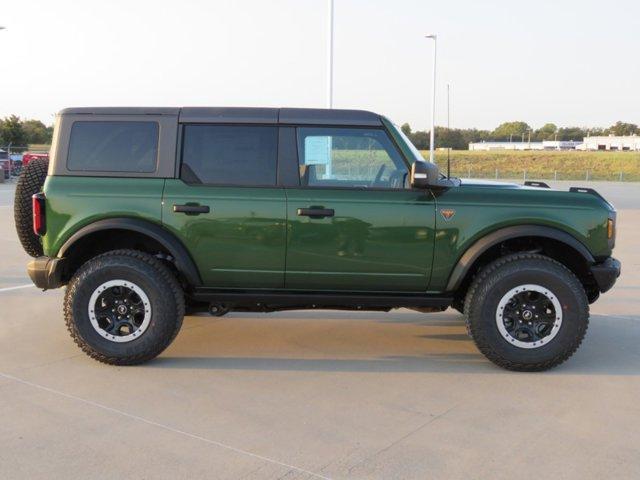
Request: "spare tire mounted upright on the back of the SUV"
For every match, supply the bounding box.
[13,158,49,257]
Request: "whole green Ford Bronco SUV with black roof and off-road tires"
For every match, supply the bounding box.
[15,108,620,371]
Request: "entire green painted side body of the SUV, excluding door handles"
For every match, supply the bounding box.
[43,151,612,292]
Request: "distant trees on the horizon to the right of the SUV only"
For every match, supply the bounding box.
[401,122,640,150]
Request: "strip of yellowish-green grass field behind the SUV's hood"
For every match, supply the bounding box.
[422,150,640,182]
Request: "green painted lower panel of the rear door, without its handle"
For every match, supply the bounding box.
[162,179,286,288]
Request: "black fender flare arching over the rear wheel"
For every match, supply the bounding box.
[58,218,202,287]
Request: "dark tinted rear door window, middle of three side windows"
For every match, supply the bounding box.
[180,125,278,185]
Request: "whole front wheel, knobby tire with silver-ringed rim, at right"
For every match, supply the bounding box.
[464,254,589,371]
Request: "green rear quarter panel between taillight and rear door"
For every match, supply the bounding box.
[43,176,164,257]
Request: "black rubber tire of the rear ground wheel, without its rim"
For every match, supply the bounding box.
[64,250,185,365]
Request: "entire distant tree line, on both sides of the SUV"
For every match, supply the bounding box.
[0,115,640,150]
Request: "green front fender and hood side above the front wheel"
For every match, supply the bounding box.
[429,181,611,291]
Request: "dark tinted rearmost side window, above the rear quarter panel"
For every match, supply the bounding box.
[67,122,159,173]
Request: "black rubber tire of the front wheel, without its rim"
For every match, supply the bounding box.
[464,253,589,371]
